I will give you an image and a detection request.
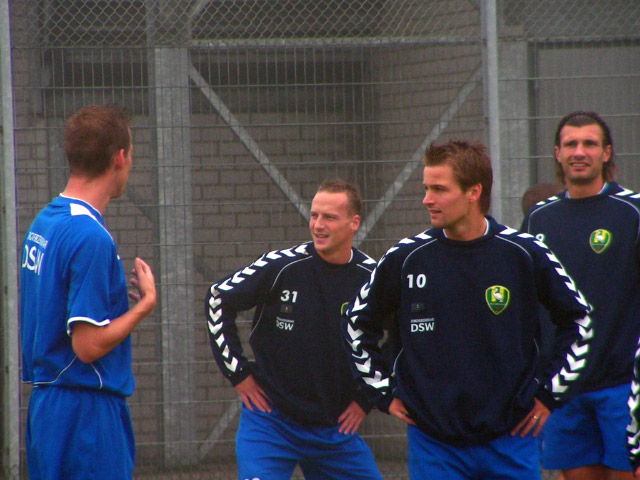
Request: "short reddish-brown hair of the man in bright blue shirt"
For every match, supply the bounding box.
[64,105,131,178]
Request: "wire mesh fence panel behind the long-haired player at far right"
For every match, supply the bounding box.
[500,0,640,225]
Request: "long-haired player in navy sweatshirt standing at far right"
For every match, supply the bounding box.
[523,112,640,480]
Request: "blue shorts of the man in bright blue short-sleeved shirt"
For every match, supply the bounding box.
[26,387,135,480]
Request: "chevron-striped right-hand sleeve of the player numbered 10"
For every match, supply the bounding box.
[525,234,594,409]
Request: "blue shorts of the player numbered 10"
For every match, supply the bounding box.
[408,425,540,480]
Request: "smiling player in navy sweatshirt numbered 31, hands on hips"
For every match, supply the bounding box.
[205,180,382,480]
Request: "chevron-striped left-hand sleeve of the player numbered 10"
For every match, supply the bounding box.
[342,240,410,413]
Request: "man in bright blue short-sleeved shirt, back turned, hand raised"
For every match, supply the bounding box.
[20,106,156,480]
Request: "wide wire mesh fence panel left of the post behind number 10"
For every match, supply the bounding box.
[5,0,483,478]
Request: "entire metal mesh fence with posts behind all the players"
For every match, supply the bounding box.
[0,0,640,479]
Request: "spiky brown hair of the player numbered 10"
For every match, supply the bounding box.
[422,141,493,213]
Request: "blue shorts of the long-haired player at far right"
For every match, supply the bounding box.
[540,383,631,471]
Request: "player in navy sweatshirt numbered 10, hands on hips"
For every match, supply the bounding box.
[343,142,592,480]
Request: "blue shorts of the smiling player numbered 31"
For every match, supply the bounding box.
[236,405,382,480]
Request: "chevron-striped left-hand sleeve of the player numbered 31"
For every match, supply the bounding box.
[205,252,274,386]
